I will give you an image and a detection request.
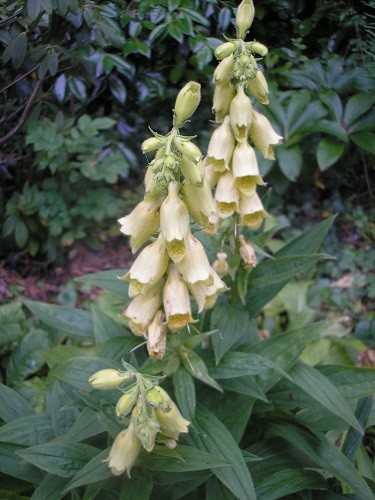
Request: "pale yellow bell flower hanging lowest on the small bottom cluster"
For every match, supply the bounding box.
[107,423,142,477]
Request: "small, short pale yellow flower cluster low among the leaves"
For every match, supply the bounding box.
[89,363,190,476]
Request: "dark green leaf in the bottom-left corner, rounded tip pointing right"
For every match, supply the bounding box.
[0,443,43,484]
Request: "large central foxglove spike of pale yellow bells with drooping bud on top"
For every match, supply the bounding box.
[119,82,227,358]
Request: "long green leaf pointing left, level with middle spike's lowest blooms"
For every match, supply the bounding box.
[23,300,94,341]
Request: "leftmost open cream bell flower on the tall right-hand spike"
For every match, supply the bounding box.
[205,116,234,172]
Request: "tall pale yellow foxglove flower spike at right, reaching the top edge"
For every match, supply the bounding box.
[204,0,282,230]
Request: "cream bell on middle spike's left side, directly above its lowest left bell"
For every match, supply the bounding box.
[121,234,169,297]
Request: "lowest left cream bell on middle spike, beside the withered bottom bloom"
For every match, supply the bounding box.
[122,280,164,337]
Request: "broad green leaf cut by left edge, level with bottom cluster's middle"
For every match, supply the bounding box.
[0,413,55,446]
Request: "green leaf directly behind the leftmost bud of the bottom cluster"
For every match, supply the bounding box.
[49,357,121,392]
